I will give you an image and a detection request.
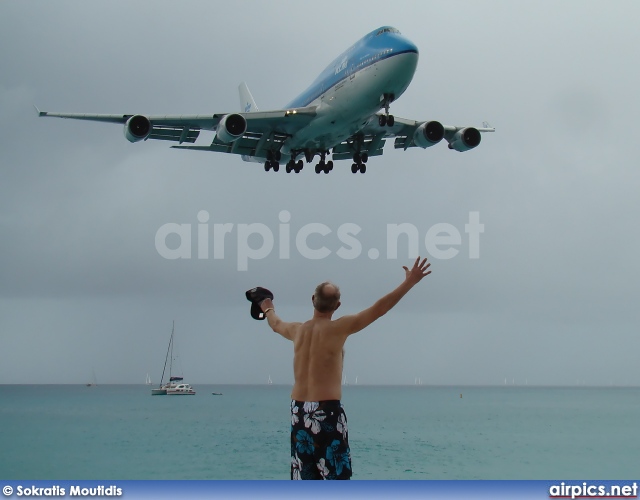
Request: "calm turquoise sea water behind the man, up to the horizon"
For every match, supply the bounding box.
[0,384,640,480]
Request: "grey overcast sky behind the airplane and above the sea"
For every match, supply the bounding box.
[0,0,640,389]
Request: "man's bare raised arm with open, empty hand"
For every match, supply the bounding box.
[337,257,431,335]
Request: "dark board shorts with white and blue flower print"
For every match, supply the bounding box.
[291,400,351,479]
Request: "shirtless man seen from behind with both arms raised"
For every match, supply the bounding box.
[260,257,431,479]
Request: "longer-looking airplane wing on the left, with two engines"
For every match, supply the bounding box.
[36,106,316,157]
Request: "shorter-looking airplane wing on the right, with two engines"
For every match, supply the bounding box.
[333,115,495,160]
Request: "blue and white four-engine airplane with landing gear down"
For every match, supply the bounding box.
[36,26,495,174]
